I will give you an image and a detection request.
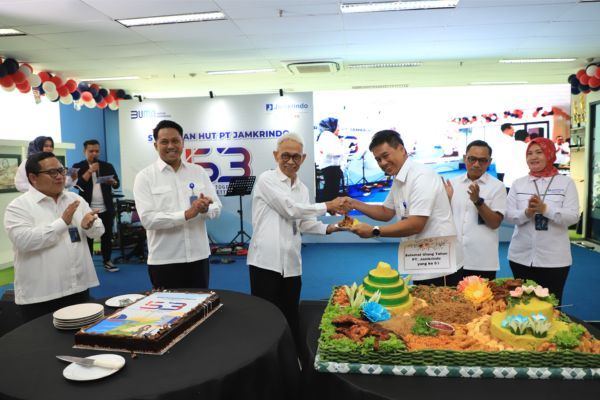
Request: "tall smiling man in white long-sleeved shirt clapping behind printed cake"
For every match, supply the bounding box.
[133,120,222,289]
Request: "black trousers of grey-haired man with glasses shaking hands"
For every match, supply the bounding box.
[249,265,302,350]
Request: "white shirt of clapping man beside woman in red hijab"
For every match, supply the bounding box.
[450,172,506,271]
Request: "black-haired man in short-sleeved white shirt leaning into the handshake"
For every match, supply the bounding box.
[350,130,462,286]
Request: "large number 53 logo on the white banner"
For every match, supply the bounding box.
[184,147,252,182]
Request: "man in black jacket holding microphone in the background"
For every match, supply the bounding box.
[73,139,119,272]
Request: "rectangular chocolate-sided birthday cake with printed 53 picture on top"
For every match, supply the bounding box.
[75,291,222,354]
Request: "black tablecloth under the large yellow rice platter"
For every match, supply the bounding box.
[300,301,600,400]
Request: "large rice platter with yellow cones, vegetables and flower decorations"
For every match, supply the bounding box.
[315,265,600,379]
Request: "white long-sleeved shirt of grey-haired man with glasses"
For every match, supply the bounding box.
[247,168,327,278]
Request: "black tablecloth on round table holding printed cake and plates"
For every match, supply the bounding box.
[0,290,300,400]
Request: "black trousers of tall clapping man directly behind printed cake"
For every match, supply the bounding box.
[148,258,210,289]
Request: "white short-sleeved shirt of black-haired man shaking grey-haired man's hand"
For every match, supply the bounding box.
[383,158,462,281]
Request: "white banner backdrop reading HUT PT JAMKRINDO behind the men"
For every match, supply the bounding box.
[119,93,315,243]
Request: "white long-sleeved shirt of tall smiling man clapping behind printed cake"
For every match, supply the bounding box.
[133,158,222,265]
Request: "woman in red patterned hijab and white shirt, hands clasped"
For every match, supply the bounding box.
[506,138,579,302]
